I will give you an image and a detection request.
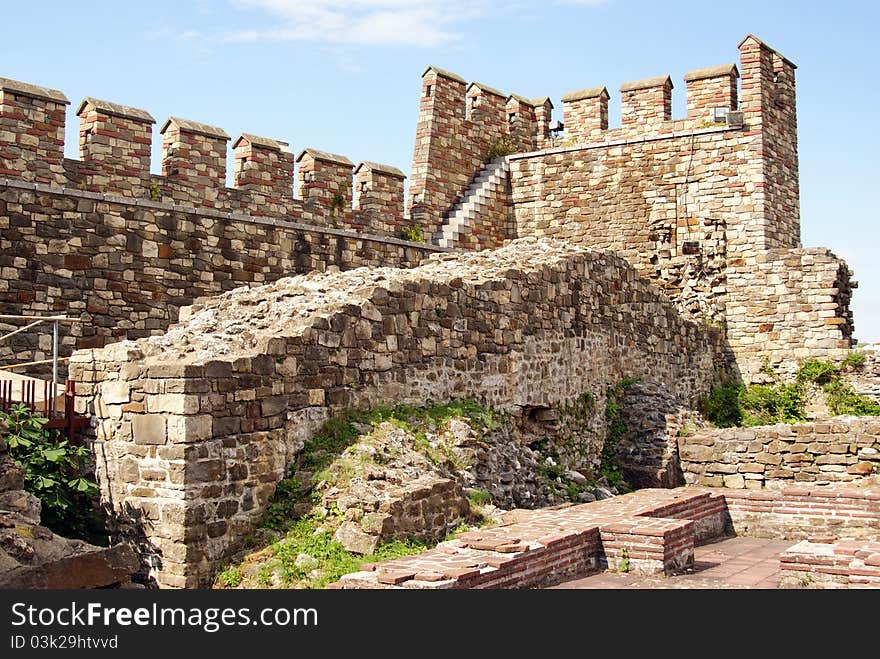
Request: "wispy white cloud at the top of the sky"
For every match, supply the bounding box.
[226,0,474,46]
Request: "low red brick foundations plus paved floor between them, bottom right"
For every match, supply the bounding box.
[329,486,880,589]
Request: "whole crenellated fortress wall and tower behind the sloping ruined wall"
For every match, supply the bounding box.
[0,36,854,378]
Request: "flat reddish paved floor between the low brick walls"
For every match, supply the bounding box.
[554,538,796,589]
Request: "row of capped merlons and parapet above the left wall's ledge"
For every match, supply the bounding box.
[0,78,410,234]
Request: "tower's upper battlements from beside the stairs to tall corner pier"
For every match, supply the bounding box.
[410,35,800,253]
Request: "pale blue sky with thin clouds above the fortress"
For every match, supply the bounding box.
[0,0,880,341]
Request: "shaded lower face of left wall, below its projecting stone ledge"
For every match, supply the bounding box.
[0,180,439,372]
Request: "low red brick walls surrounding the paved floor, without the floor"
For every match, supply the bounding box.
[332,487,880,589]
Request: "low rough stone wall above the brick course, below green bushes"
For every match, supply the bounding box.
[678,417,880,489]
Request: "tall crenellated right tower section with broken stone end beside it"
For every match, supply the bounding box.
[411,35,854,378]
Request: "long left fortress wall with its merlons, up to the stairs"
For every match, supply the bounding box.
[0,79,439,363]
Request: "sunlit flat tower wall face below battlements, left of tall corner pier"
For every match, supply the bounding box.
[509,122,740,319]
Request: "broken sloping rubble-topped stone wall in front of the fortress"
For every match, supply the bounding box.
[71,240,718,586]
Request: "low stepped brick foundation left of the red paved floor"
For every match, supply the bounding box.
[331,488,723,589]
